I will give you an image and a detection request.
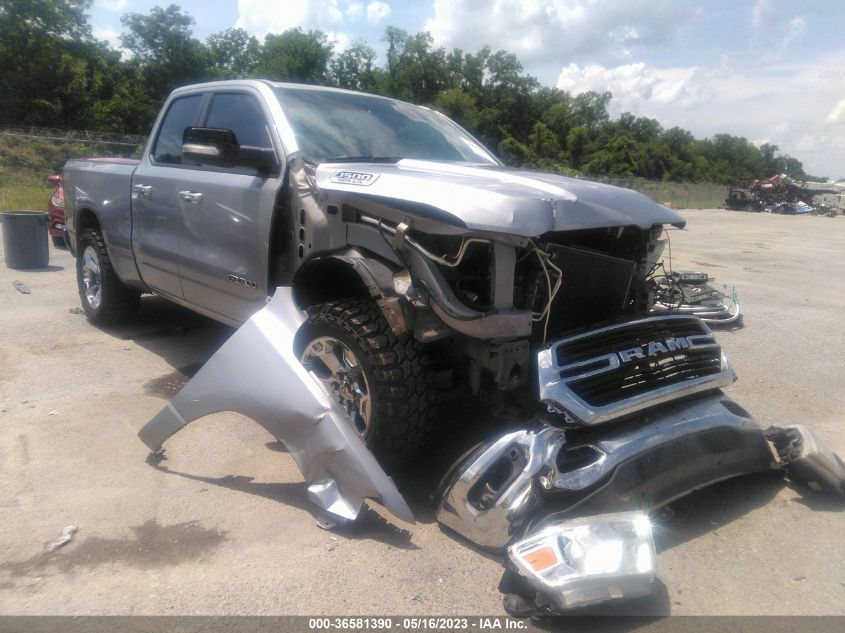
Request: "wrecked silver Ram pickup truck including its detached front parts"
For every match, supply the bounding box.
[64,81,842,612]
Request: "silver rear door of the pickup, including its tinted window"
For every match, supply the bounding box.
[132,94,203,299]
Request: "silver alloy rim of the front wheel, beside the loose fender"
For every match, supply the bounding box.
[299,336,372,438]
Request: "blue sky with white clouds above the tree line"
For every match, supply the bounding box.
[90,0,845,178]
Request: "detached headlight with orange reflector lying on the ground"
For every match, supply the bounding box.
[508,512,657,610]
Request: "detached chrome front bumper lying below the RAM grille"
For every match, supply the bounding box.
[437,393,774,549]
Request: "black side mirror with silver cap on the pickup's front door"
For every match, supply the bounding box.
[182,127,276,172]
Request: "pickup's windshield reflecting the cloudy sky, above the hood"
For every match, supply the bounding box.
[274,88,499,165]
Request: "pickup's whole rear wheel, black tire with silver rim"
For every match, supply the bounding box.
[76,229,141,325]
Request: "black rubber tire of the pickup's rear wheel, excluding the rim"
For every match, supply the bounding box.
[76,229,141,325]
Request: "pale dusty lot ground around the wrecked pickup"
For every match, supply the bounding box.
[0,210,845,615]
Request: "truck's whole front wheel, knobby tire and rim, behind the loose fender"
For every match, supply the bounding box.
[297,299,438,468]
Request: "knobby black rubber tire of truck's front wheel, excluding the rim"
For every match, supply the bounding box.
[302,299,439,469]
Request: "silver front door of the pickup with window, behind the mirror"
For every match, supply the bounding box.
[177,89,281,322]
